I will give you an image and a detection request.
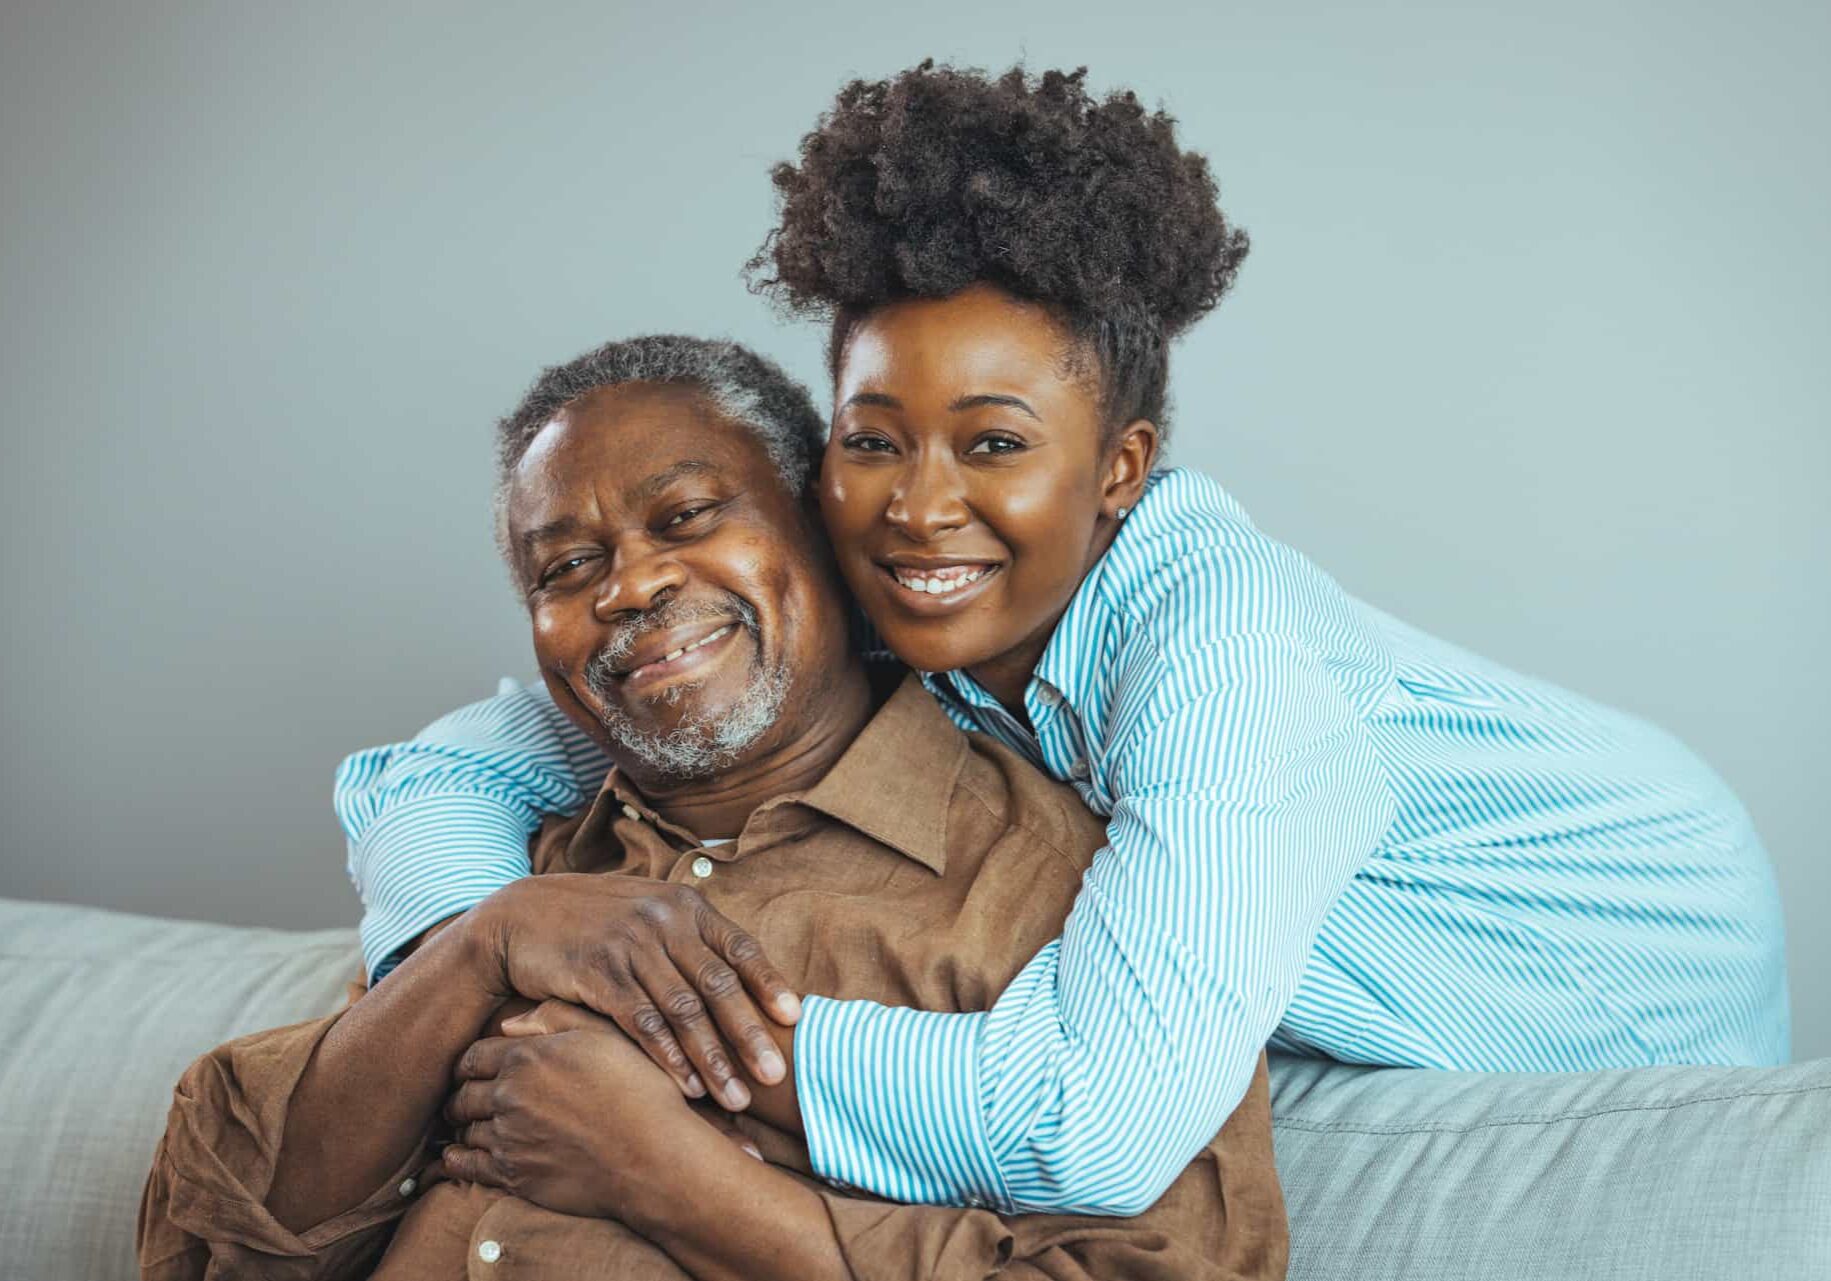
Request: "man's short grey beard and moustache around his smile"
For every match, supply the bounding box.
[586,602,789,780]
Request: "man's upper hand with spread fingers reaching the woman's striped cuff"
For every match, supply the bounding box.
[476,873,800,1111]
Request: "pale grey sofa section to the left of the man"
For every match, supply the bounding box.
[0,899,361,1281]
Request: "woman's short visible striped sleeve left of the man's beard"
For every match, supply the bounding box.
[331,679,610,983]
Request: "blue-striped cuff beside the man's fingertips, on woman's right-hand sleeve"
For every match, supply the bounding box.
[795,996,1011,1211]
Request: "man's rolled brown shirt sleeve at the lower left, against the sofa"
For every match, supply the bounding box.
[139,1014,430,1281]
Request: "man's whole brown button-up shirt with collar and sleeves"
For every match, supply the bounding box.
[139,677,1287,1281]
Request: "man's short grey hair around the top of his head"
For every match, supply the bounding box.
[493,333,826,569]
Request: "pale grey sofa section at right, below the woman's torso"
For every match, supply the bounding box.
[1273,1058,1831,1281]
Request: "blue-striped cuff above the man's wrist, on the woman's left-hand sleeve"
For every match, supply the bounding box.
[350,794,529,985]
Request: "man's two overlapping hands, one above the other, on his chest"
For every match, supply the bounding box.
[439,875,798,1221]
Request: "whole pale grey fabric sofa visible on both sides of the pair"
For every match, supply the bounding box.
[0,900,1831,1281]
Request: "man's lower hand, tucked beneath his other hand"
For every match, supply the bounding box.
[439,1001,743,1219]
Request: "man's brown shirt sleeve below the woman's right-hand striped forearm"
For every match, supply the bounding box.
[820,1054,1287,1281]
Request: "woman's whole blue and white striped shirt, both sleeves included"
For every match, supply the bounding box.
[337,470,1787,1213]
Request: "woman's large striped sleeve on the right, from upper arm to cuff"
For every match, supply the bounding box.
[795,567,1395,1215]
